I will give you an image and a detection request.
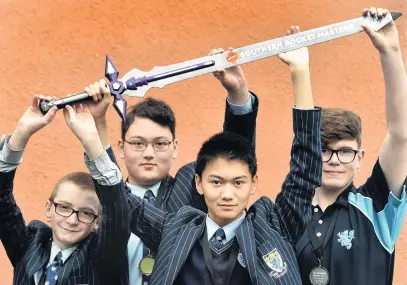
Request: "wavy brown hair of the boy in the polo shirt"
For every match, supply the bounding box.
[321,108,362,147]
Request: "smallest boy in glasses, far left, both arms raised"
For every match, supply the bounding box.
[0,96,130,285]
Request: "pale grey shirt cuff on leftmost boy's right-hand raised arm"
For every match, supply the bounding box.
[85,151,122,186]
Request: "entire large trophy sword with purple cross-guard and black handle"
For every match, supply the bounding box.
[40,12,402,122]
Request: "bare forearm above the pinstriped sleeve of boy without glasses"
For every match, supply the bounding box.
[290,66,314,109]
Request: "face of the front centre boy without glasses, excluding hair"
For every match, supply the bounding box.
[195,157,257,226]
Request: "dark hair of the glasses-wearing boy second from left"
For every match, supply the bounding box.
[122,98,175,140]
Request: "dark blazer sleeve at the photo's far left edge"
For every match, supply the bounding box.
[0,170,30,267]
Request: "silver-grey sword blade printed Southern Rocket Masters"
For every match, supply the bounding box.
[121,13,401,97]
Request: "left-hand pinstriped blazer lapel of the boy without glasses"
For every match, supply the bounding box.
[165,222,205,285]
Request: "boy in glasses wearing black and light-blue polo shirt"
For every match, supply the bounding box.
[296,8,407,285]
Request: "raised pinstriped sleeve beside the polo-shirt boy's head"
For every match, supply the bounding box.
[275,108,322,243]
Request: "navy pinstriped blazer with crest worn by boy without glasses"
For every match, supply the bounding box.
[129,109,322,285]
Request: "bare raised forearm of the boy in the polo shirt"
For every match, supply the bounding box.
[380,50,407,141]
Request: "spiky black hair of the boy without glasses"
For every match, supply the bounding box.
[195,132,257,177]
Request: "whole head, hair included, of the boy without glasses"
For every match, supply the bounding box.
[195,132,257,227]
